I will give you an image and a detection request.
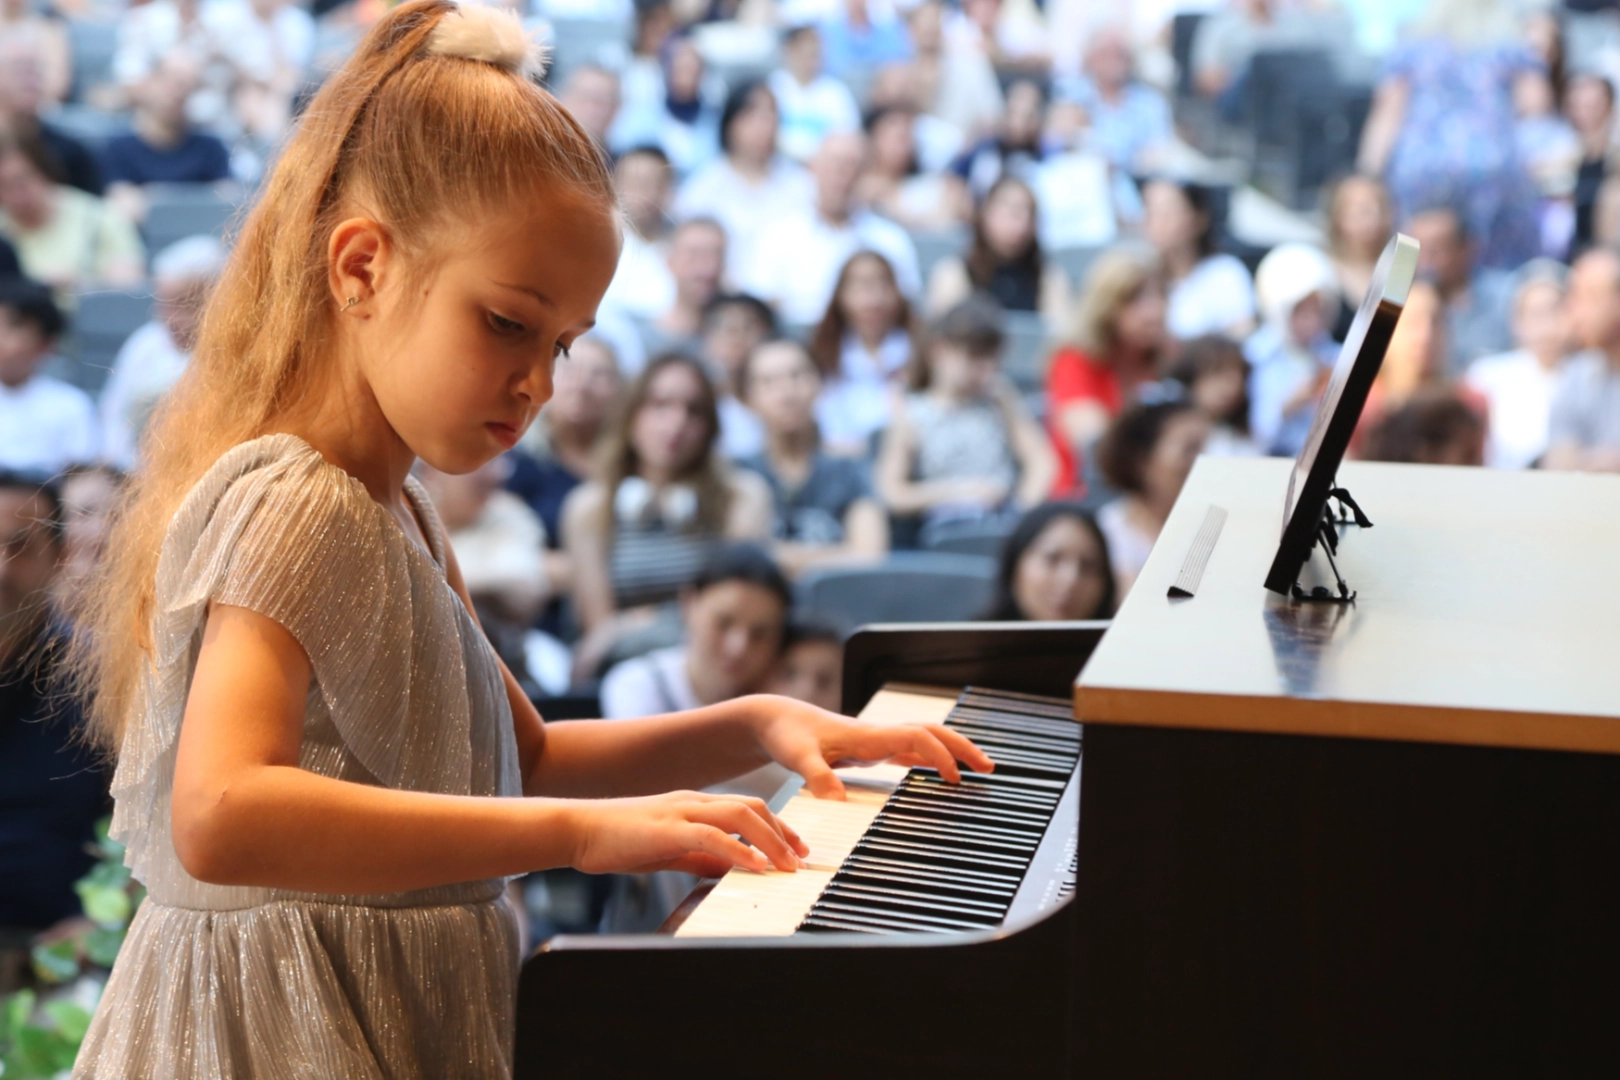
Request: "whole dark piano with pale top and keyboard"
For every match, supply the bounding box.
[517,458,1620,1080]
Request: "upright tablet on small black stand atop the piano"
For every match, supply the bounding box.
[1265,233,1418,602]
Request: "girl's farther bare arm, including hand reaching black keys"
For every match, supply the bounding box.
[446,549,995,798]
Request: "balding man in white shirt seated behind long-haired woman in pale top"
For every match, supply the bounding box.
[739,133,922,324]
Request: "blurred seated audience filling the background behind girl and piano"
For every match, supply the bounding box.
[9,0,1620,965]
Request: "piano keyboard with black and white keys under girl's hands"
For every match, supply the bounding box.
[676,687,1081,938]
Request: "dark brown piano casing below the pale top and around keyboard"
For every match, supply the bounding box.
[517,625,1620,1080]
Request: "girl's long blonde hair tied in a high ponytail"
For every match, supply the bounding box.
[66,0,616,753]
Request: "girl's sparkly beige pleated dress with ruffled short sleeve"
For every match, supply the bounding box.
[73,436,522,1080]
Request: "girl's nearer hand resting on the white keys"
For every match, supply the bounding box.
[572,792,810,878]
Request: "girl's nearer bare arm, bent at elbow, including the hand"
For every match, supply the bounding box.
[170,606,807,894]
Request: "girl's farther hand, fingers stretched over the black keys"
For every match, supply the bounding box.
[753,695,996,798]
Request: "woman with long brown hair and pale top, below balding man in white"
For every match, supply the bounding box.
[810,251,915,457]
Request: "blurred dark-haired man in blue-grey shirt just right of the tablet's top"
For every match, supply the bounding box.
[1403,206,1513,374]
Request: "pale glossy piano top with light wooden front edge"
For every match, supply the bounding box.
[1074,457,1620,753]
